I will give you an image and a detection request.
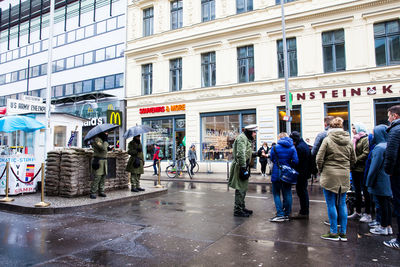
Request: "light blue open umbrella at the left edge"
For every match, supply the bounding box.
[0,116,46,133]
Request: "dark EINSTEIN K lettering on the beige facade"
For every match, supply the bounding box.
[280,85,393,102]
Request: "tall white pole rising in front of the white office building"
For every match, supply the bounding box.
[44,0,54,160]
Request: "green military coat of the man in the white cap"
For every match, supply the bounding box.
[228,133,252,191]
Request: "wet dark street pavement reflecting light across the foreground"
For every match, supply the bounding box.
[0,181,400,266]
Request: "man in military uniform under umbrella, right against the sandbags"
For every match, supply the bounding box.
[90,133,108,199]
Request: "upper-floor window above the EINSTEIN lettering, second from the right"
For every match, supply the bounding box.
[322,29,346,73]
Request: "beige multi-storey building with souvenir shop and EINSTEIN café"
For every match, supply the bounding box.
[126,0,400,171]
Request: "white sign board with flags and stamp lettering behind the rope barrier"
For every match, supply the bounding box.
[0,155,42,195]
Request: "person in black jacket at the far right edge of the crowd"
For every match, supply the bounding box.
[383,105,400,249]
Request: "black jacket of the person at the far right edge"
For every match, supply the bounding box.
[385,119,400,176]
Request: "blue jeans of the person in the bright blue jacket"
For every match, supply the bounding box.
[272,181,292,216]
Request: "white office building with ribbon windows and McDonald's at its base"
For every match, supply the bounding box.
[0,0,127,151]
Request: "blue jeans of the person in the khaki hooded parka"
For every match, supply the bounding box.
[324,189,347,234]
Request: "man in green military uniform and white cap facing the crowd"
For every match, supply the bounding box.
[228,124,257,217]
